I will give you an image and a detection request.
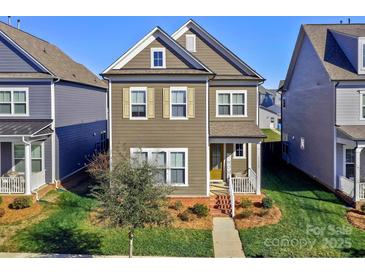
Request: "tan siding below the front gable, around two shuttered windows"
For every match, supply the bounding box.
[112,83,207,196]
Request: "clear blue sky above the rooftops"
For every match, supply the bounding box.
[0,16,365,88]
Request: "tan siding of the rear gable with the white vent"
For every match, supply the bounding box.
[177,31,245,75]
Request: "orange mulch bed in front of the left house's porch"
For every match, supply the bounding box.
[0,196,43,224]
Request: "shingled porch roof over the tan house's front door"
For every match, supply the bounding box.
[209,121,266,138]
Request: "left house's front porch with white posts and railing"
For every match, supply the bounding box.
[0,120,53,195]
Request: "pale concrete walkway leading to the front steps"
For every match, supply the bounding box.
[213,217,245,258]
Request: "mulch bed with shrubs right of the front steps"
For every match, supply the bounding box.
[234,198,281,229]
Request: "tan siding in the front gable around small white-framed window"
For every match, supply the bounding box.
[123,40,190,69]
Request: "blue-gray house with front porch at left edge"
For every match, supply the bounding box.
[0,22,107,195]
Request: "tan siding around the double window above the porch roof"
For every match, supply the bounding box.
[209,86,257,121]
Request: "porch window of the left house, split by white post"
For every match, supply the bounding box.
[13,144,43,173]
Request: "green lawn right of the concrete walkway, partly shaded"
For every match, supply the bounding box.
[239,165,365,257]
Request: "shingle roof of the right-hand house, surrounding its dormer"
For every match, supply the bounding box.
[303,24,365,80]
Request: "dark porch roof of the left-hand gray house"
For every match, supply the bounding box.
[0,119,52,136]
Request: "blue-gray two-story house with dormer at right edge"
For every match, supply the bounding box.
[282,24,365,207]
